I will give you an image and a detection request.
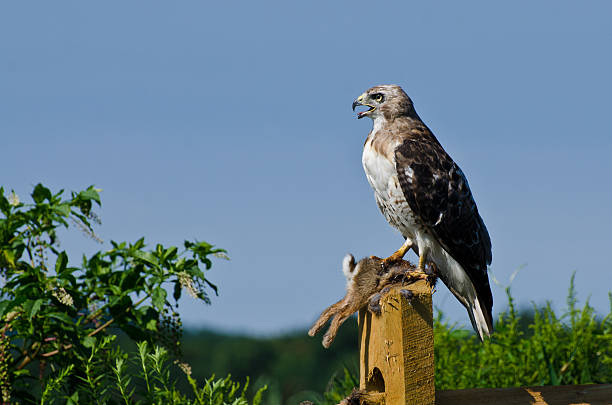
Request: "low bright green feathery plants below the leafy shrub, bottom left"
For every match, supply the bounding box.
[35,337,266,405]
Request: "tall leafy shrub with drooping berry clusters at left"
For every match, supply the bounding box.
[0,184,244,403]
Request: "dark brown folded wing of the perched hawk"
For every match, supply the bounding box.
[395,138,493,311]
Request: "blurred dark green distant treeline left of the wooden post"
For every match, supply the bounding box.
[177,317,359,404]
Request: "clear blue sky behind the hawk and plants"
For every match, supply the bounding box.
[0,0,612,334]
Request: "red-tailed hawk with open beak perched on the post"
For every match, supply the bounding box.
[353,85,493,339]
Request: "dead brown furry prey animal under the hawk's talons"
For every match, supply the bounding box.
[308,253,436,348]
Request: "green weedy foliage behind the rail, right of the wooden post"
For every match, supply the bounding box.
[434,277,612,389]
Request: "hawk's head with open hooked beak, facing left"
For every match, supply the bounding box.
[353,84,416,121]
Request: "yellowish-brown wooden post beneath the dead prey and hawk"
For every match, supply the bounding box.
[359,281,435,405]
